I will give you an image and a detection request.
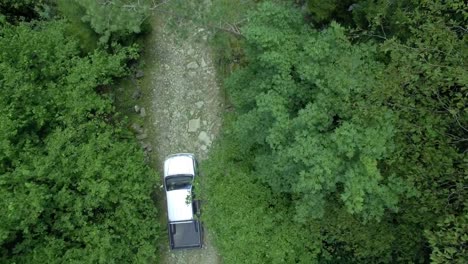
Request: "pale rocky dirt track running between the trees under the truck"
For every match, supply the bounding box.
[143,9,223,264]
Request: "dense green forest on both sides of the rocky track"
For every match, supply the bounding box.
[0,0,468,264]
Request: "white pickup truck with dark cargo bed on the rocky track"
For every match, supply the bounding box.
[164,153,202,249]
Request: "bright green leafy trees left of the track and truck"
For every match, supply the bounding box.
[0,21,159,263]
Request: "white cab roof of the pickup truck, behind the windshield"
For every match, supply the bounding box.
[167,189,193,222]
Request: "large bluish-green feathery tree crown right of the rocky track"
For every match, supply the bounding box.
[228,1,405,221]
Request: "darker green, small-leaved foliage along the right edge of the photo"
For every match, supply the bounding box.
[375,1,468,263]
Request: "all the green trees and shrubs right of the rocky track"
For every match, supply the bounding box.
[203,0,468,263]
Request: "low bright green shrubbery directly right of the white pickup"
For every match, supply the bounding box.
[202,129,320,263]
